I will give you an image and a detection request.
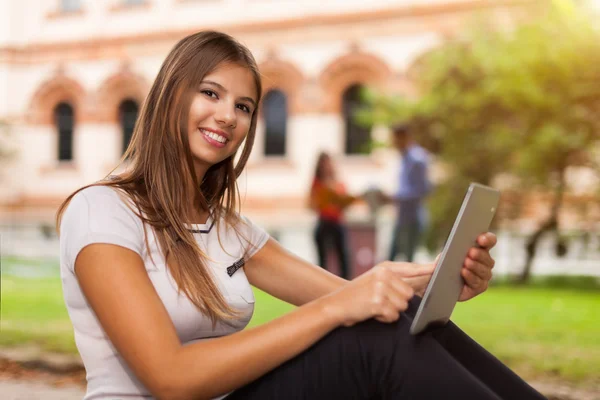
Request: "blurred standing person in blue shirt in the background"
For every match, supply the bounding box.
[383,124,431,262]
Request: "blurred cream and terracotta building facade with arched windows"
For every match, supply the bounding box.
[0,0,536,223]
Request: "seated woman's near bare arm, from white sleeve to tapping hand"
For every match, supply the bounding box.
[75,244,413,400]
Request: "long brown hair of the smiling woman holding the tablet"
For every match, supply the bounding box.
[56,31,262,324]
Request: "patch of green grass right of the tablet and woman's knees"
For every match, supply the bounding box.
[452,287,600,382]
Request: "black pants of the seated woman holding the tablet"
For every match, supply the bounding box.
[227,297,545,400]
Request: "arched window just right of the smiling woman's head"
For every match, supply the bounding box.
[263,89,287,156]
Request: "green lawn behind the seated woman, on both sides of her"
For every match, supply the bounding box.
[0,262,600,385]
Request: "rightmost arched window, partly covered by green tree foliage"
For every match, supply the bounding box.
[342,85,371,154]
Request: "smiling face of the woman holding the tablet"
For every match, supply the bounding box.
[188,64,257,173]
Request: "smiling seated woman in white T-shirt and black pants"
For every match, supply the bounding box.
[57,32,542,400]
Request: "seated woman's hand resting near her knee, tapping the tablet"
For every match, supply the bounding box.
[322,263,414,326]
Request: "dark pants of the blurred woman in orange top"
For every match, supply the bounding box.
[315,218,350,279]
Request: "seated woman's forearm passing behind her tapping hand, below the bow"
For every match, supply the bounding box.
[244,239,348,306]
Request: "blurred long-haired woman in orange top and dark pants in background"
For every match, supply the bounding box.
[310,153,356,279]
